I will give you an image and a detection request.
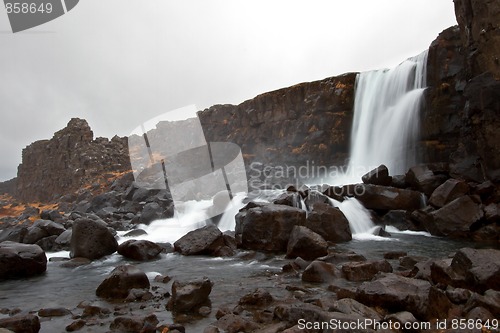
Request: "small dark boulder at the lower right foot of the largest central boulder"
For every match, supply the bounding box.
[286,226,328,260]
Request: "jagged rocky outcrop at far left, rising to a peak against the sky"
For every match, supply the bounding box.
[15,118,130,202]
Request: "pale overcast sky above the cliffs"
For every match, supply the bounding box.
[0,0,456,180]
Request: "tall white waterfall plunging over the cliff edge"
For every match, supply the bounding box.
[348,51,428,176]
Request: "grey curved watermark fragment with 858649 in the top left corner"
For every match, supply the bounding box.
[4,0,79,33]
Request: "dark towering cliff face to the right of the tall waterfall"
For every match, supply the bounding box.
[422,0,500,181]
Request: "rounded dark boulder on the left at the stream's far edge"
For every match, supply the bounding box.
[70,218,118,260]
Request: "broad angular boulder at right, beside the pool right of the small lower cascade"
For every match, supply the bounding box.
[424,196,484,238]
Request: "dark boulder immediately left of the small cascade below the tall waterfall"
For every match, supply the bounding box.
[305,203,352,243]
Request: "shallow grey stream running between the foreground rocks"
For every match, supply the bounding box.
[0,224,492,333]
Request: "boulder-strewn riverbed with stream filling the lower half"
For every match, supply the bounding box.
[0,164,500,332]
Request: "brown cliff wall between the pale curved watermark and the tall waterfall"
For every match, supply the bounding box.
[199,73,356,184]
